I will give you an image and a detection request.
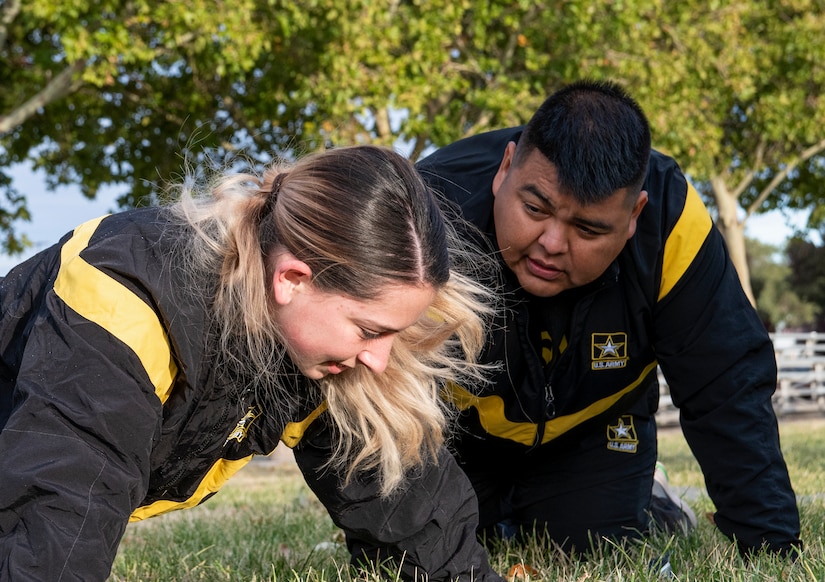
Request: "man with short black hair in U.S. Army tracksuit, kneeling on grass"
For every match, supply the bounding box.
[418,81,801,554]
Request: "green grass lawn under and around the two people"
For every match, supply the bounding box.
[109,420,825,582]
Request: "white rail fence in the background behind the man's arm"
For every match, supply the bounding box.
[656,333,825,426]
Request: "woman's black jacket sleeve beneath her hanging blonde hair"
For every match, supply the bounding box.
[295,422,503,582]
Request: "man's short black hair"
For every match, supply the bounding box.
[514,80,650,204]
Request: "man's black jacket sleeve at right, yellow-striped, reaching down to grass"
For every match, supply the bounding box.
[654,174,801,554]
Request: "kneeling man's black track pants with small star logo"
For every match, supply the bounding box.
[461,415,656,551]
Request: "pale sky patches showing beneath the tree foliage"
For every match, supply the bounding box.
[0,165,807,276]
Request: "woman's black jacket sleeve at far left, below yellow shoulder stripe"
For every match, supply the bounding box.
[0,294,161,582]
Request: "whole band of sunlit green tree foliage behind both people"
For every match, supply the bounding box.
[0,0,825,310]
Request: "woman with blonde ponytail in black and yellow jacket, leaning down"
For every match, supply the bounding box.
[0,146,497,580]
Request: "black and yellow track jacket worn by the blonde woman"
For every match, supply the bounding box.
[0,209,495,582]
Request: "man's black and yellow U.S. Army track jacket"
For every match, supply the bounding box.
[418,128,799,551]
